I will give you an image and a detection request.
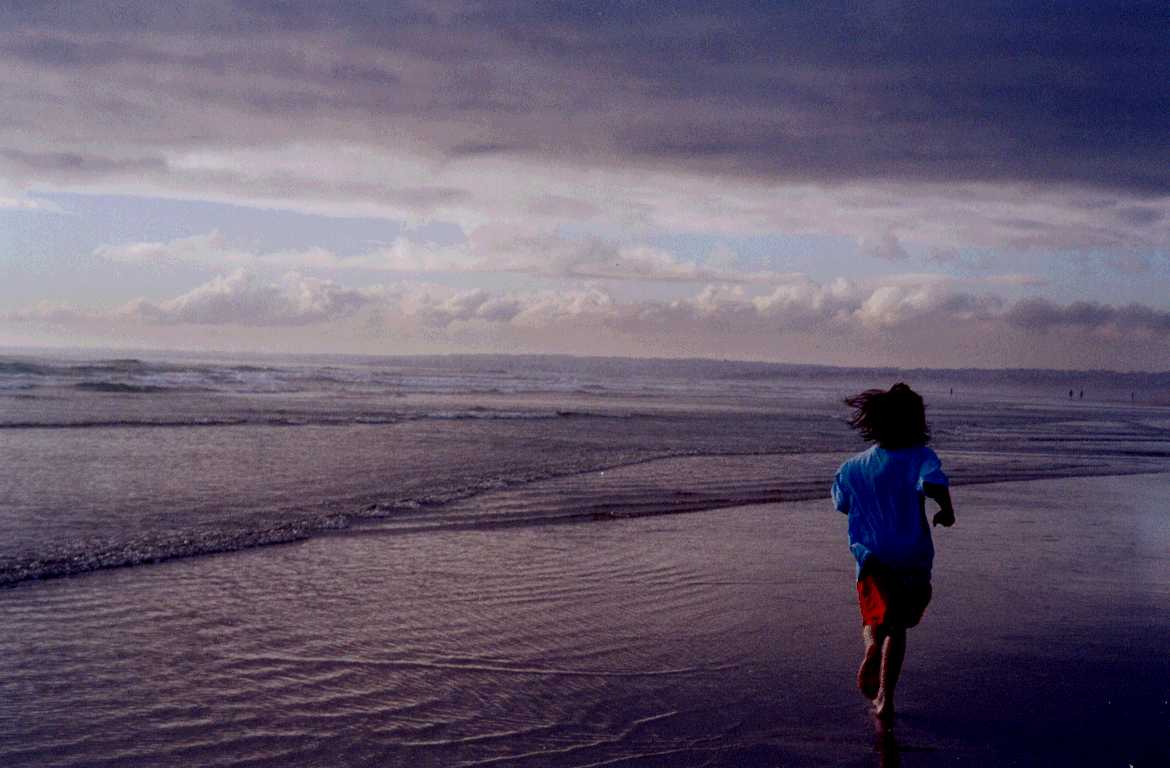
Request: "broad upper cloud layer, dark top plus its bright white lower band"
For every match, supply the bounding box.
[0,0,1170,256]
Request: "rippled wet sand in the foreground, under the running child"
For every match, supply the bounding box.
[0,474,1170,768]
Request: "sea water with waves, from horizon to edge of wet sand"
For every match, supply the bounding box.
[0,352,1170,584]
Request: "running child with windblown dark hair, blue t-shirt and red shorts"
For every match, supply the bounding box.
[833,384,955,724]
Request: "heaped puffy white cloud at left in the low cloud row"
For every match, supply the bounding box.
[118,269,378,325]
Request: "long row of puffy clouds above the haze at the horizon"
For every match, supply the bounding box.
[25,269,1170,339]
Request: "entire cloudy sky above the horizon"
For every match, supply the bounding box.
[0,0,1170,370]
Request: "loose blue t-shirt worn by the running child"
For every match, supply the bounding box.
[833,445,948,574]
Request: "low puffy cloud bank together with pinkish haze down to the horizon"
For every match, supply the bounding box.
[9,269,1170,369]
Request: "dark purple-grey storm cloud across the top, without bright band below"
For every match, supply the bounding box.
[0,0,1170,192]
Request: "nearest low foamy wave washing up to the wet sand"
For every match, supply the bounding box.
[0,453,1170,587]
